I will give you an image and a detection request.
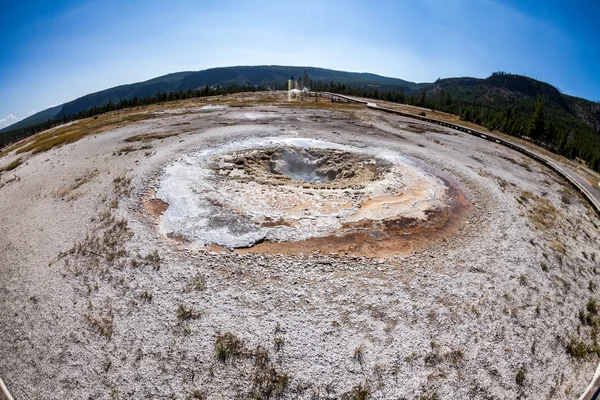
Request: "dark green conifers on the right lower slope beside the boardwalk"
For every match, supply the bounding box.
[318,77,600,172]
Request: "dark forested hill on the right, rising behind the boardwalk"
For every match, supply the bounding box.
[324,72,600,172]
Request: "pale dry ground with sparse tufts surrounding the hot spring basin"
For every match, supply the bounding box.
[0,94,600,399]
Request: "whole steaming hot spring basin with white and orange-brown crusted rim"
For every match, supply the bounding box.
[149,138,469,257]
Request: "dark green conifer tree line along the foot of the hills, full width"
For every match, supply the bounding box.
[0,71,600,172]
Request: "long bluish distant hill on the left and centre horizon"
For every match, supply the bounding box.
[0,66,418,132]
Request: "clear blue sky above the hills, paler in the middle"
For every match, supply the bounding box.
[0,0,600,127]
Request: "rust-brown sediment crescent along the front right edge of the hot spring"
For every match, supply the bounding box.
[235,178,473,258]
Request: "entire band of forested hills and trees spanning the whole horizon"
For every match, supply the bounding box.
[0,66,600,171]
